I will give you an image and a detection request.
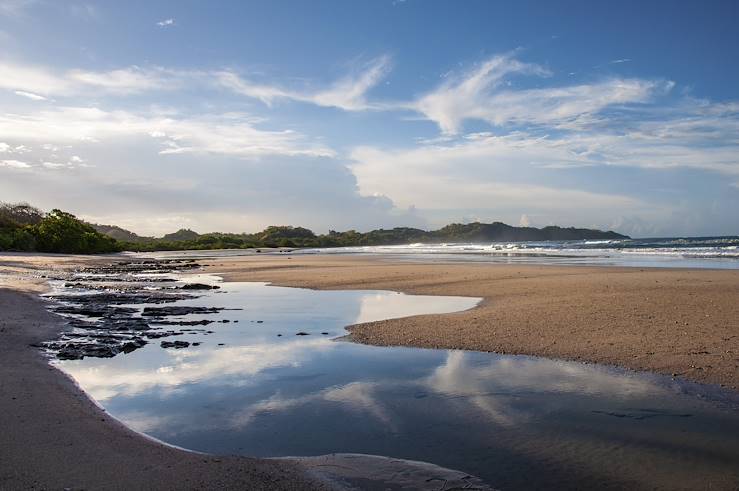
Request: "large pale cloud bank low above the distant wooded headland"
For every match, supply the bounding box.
[351,135,656,230]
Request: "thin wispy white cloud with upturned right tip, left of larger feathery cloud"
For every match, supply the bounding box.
[215,56,390,111]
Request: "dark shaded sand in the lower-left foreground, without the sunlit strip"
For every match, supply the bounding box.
[0,288,329,490]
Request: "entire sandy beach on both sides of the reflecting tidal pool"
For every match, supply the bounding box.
[0,254,739,489]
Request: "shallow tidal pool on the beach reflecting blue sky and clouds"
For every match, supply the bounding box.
[59,275,739,489]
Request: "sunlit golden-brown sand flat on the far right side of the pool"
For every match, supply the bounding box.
[203,254,739,390]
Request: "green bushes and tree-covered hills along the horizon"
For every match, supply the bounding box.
[0,203,627,254]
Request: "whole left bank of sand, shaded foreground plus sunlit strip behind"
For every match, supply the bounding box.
[0,254,498,491]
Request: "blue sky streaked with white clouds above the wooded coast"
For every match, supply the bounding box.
[0,0,739,237]
